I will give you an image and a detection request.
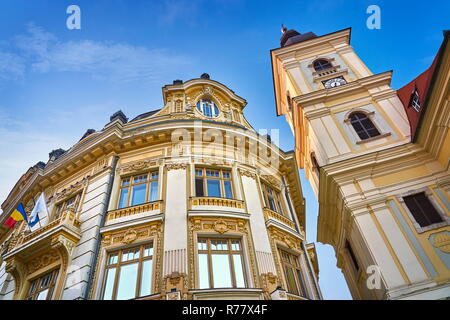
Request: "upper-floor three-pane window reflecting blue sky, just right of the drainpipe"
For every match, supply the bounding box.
[117,171,158,209]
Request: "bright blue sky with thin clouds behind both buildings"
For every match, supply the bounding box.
[0,0,450,299]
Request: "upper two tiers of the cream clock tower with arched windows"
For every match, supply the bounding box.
[271,28,410,195]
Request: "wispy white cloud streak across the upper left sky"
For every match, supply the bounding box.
[0,23,191,83]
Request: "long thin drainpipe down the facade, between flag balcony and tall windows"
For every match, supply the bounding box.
[81,156,119,300]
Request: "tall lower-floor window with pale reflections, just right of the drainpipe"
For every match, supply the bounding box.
[102,244,153,300]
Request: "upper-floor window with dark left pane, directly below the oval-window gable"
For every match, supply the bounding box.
[195,168,233,199]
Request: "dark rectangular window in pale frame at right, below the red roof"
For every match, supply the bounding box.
[403,192,443,228]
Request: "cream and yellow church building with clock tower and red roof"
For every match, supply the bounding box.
[271,29,450,299]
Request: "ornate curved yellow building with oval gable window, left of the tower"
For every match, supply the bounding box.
[0,74,321,300]
